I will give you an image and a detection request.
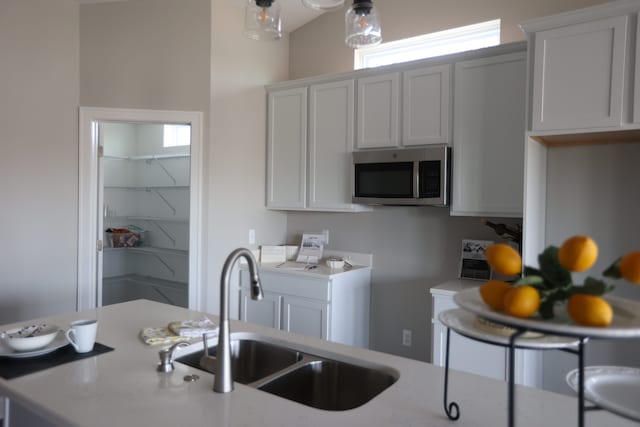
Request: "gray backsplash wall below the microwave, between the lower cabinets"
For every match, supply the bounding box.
[287,206,519,361]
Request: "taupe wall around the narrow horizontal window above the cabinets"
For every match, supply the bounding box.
[290,0,605,79]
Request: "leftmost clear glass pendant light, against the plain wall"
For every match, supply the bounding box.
[244,0,282,40]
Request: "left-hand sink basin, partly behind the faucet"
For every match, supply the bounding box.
[176,339,302,384]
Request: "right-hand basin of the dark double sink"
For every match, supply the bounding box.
[259,360,397,411]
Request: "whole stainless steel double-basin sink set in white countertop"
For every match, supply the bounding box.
[176,333,399,411]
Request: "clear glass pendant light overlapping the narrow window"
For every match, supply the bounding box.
[344,0,382,49]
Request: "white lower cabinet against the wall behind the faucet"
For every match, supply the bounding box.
[240,267,371,347]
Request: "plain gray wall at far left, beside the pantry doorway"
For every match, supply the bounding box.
[0,0,79,323]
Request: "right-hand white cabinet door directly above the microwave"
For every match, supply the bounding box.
[402,64,451,146]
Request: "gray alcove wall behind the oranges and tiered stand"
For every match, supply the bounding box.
[543,142,640,392]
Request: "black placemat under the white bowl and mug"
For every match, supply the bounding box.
[0,342,113,380]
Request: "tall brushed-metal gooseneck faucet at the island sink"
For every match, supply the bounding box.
[212,248,262,393]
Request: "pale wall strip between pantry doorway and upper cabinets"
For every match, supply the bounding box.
[205,0,289,316]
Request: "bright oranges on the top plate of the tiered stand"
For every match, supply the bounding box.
[480,236,640,327]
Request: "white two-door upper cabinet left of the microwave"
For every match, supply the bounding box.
[267,79,370,212]
